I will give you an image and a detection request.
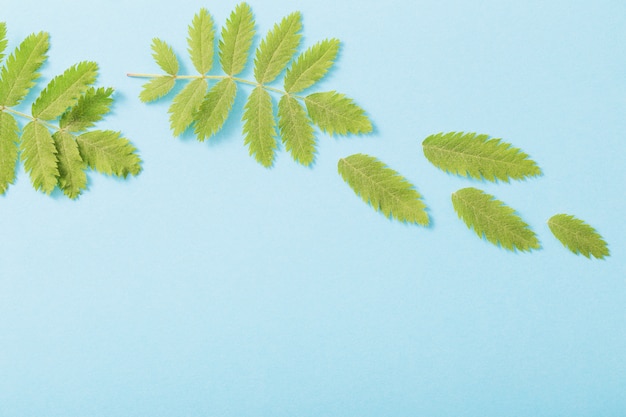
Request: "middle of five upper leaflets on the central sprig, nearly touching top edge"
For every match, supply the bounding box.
[219,3,255,75]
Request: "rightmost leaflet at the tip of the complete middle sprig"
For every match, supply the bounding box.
[304,91,372,135]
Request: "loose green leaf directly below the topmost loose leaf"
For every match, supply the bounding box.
[452,187,540,251]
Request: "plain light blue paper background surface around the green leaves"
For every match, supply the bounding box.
[0,0,626,417]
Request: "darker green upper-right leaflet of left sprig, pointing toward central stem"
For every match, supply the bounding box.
[59,87,114,132]
